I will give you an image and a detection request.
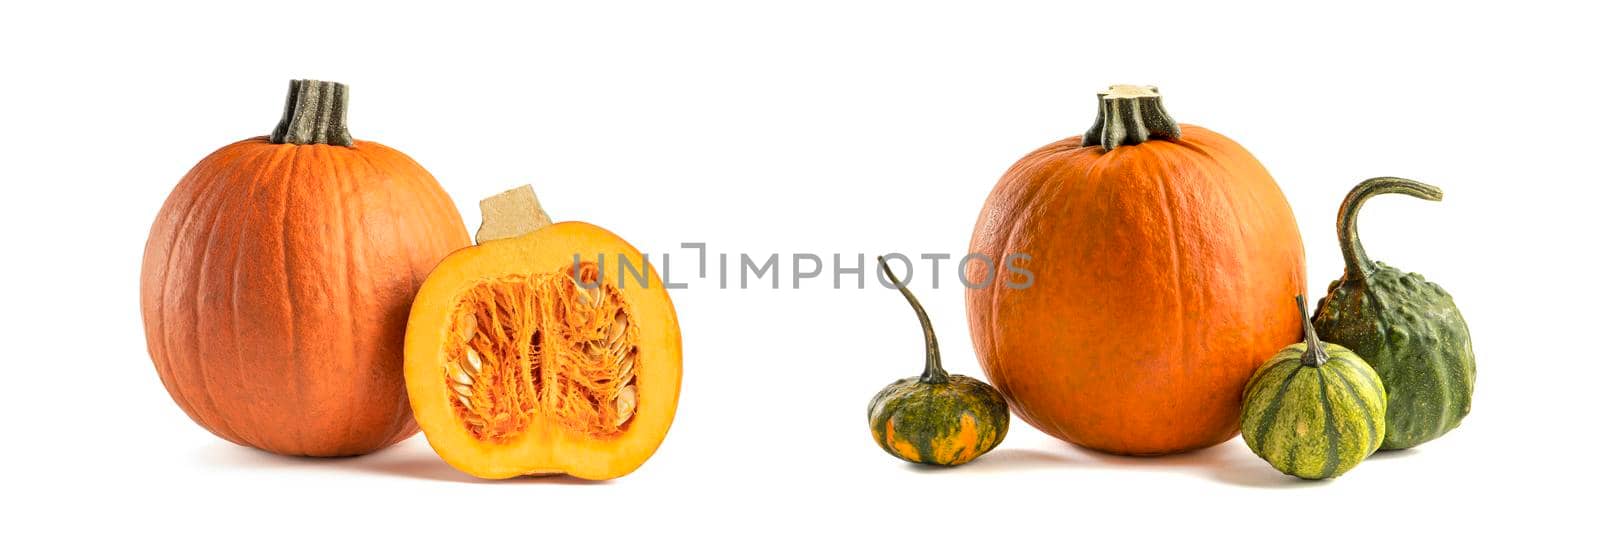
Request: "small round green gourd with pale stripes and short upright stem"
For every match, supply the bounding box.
[1240,296,1387,479]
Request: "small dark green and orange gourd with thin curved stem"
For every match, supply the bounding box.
[867,258,1011,466]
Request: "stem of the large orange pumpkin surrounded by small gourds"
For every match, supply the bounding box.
[1083,85,1182,152]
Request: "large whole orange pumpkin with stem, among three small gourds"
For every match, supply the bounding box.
[966,85,1306,455]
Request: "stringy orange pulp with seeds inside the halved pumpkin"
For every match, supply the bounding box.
[440,262,638,443]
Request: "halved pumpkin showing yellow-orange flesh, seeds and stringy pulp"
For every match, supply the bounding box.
[405,186,683,479]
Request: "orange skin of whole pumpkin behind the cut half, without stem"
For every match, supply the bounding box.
[141,138,469,456]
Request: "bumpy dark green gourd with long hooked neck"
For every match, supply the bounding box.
[1315,178,1478,450]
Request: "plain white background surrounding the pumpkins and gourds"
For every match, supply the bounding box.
[0,2,1600,531]
